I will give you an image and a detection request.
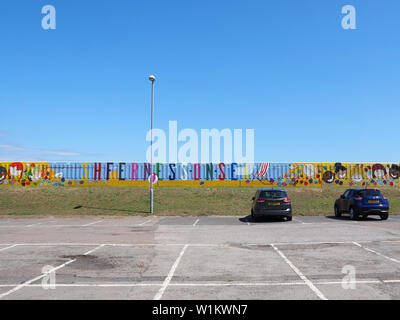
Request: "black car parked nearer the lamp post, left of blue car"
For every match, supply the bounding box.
[251,188,292,221]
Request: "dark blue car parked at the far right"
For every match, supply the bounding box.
[335,189,389,220]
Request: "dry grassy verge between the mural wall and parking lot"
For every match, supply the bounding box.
[0,187,400,216]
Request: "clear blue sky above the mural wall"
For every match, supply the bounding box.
[0,0,400,162]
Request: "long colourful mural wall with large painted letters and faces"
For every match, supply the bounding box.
[0,162,400,187]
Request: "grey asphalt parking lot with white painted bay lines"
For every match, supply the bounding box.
[0,216,400,300]
